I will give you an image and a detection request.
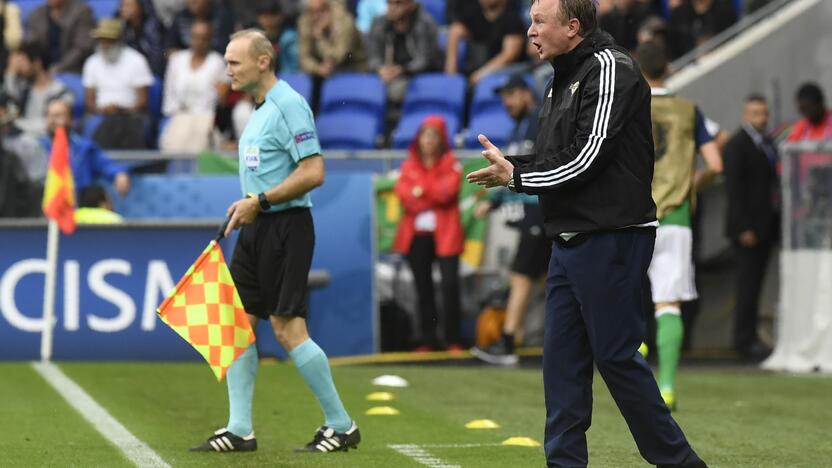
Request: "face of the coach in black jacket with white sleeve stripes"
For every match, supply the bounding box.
[528,0,581,61]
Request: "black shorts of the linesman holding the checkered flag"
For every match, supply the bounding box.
[230,208,315,319]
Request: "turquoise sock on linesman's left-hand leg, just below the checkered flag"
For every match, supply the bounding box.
[225,344,257,437]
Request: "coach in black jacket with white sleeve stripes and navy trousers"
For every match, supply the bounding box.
[468,0,706,468]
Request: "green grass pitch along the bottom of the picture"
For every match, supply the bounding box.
[0,363,832,468]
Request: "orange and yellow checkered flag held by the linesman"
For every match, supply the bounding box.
[156,241,254,381]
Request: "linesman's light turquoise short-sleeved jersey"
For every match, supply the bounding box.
[238,80,321,212]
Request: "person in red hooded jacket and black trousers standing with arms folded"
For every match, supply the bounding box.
[393,116,464,351]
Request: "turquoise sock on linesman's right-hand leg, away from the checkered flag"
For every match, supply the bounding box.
[289,338,352,432]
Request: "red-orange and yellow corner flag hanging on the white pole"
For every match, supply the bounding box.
[43,127,75,234]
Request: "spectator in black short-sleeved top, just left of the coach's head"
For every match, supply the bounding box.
[445,0,526,84]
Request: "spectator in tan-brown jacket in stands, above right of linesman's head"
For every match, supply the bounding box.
[298,0,367,79]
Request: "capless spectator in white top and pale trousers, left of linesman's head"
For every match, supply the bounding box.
[159,19,229,153]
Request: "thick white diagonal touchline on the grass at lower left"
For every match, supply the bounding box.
[32,362,170,468]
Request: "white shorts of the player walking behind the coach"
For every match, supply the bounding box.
[647,225,697,303]
